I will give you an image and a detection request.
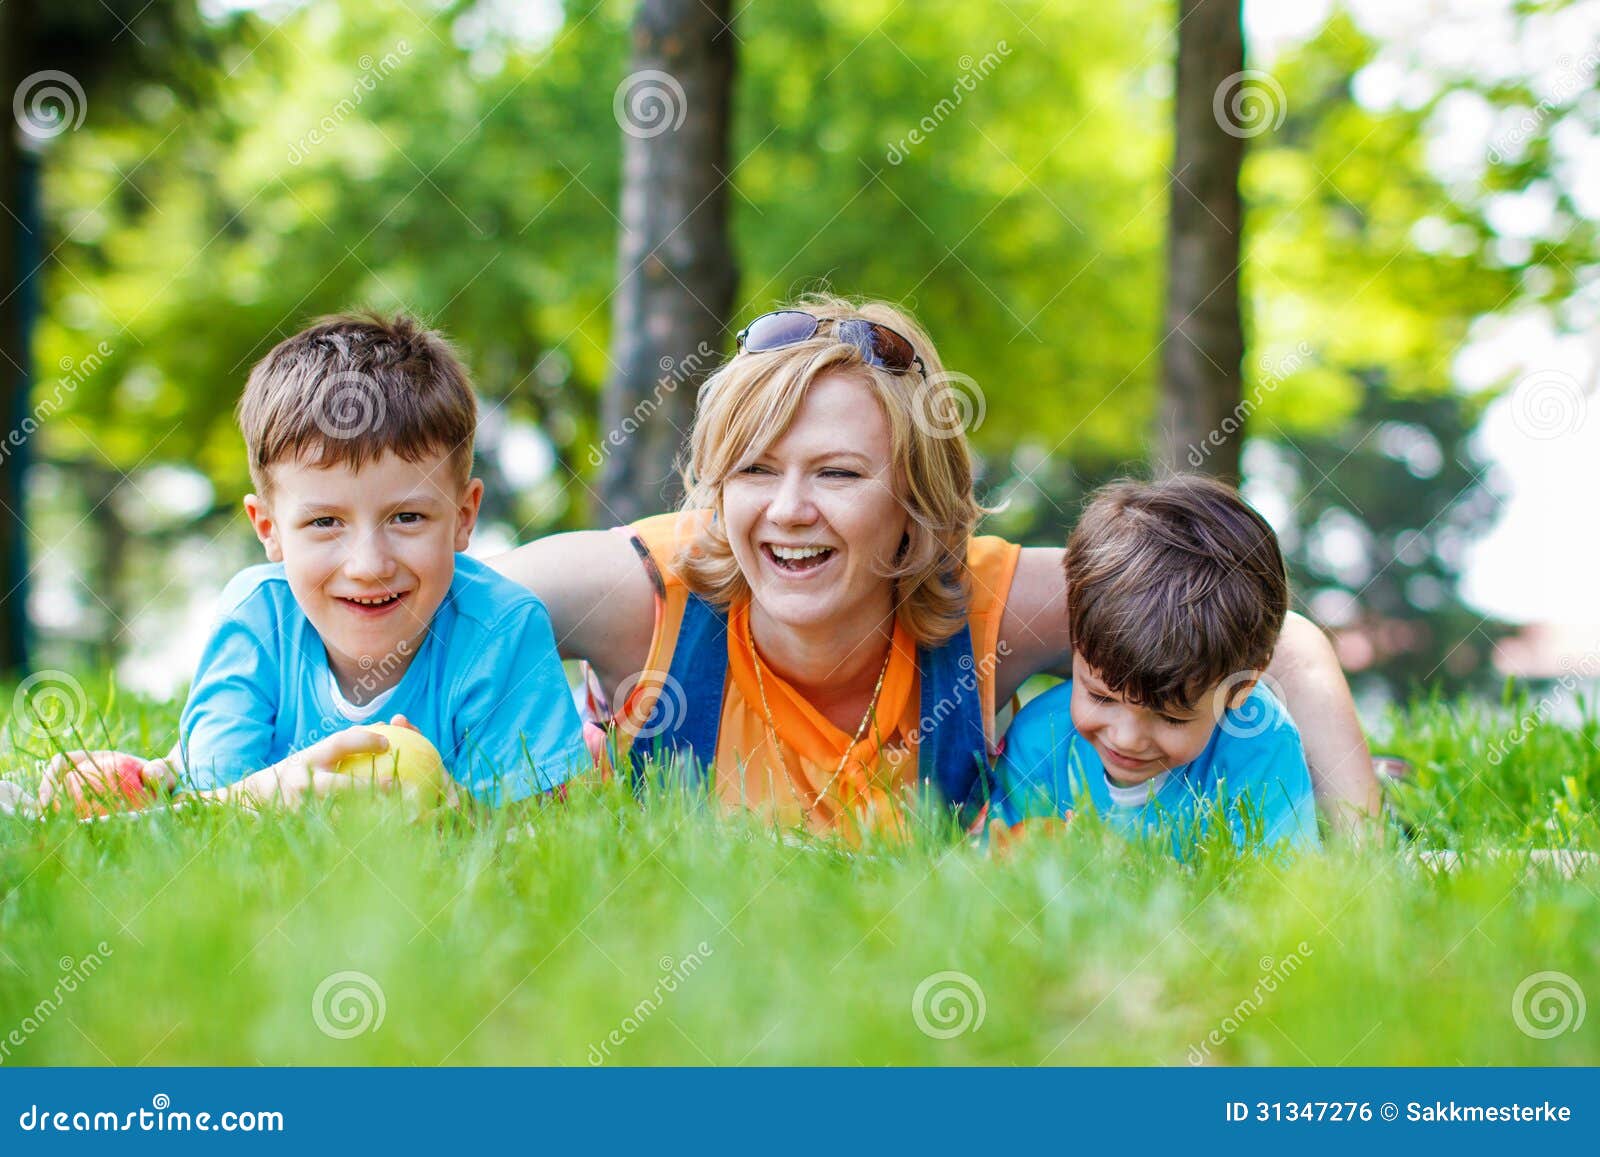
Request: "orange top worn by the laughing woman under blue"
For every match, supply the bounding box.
[590,512,1021,831]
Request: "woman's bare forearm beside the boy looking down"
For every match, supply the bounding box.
[1267,613,1382,832]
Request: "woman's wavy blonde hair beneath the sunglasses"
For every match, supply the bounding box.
[674,294,984,645]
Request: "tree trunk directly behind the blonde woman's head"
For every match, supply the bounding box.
[589,0,738,522]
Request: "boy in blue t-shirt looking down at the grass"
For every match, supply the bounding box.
[990,475,1320,855]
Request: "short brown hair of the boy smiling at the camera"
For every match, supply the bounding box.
[238,312,478,494]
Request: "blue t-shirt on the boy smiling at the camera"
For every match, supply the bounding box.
[179,555,592,803]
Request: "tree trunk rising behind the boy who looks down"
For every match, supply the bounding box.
[1155,0,1259,480]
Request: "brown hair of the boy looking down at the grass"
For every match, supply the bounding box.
[1066,474,1290,711]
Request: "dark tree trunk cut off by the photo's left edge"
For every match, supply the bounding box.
[0,0,40,680]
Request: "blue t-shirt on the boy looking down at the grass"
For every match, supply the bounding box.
[994,680,1320,856]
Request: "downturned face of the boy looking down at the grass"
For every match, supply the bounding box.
[1070,651,1254,784]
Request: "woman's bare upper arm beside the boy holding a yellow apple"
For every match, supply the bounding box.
[486,530,656,693]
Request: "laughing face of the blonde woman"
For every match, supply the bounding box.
[722,374,909,627]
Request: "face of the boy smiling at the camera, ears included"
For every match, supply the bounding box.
[245,451,483,693]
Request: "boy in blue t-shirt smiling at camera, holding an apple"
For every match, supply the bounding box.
[46,315,592,803]
